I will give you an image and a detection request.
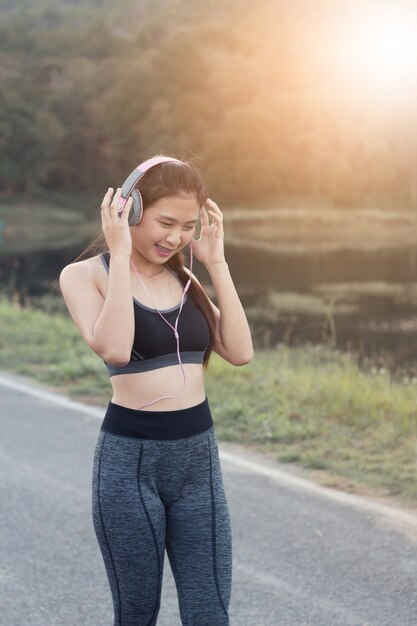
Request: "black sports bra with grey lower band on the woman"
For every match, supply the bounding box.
[100,252,210,376]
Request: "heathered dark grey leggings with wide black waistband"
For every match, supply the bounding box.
[92,399,232,626]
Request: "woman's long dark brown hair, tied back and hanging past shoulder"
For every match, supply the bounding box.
[68,154,215,368]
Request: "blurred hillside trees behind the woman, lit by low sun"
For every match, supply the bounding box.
[0,0,416,206]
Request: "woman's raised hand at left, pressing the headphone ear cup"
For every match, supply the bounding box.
[101,187,133,256]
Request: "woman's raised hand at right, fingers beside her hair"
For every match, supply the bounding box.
[192,198,225,265]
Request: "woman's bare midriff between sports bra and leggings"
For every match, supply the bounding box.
[110,363,206,411]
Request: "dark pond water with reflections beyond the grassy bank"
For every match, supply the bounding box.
[0,238,417,375]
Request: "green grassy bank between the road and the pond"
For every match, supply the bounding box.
[0,299,417,505]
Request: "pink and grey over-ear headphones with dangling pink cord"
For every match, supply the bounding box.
[118,157,193,410]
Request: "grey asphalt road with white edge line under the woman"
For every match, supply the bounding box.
[0,377,417,626]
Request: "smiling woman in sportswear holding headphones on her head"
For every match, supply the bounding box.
[60,152,253,626]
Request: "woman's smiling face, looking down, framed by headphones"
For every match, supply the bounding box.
[130,194,200,265]
